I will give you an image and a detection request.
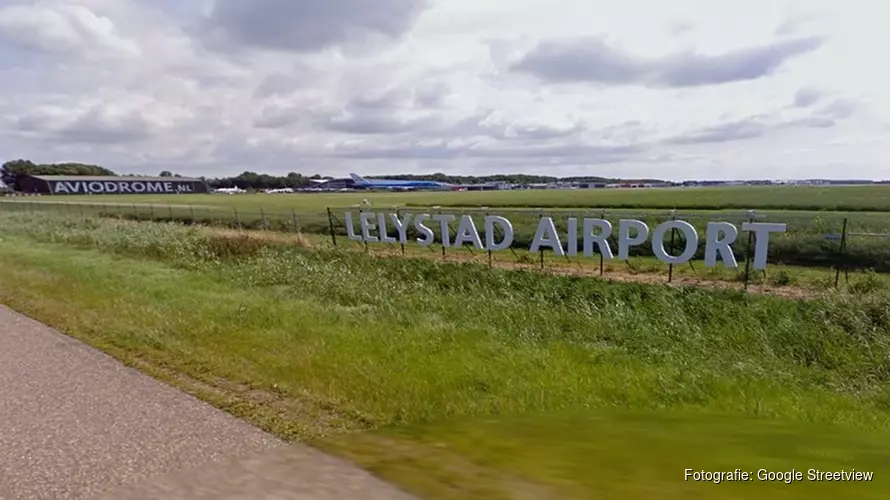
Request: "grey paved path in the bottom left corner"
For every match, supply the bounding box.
[0,305,411,500]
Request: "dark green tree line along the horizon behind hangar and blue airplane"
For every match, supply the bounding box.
[0,159,660,190]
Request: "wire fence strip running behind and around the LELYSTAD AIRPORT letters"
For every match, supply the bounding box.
[0,201,890,288]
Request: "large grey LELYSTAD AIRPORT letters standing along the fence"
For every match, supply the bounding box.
[344,211,786,269]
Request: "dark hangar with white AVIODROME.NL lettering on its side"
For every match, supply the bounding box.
[19,175,209,195]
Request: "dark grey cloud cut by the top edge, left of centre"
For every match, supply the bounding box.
[199,0,427,52]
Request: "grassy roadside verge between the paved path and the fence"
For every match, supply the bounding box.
[0,215,890,499]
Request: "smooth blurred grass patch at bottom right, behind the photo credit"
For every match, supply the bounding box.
[319,411,890,500]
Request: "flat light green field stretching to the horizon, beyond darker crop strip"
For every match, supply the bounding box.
[12,185,890,212]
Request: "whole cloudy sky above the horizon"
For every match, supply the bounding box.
[0,0,890,180]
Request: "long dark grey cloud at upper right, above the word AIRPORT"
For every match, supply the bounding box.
[510,37,823,87]
